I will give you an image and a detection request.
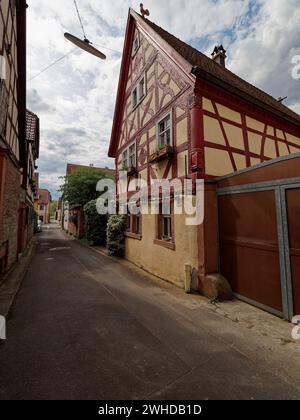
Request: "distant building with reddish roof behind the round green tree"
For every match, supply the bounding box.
[62,163,115,238]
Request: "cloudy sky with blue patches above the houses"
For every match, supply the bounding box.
[27,0,300,197]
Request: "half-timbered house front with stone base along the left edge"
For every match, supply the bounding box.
[0,0,36,273]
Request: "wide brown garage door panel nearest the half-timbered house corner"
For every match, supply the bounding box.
[219,190,282,313]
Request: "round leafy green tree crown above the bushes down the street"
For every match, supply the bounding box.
[60,168,107,206]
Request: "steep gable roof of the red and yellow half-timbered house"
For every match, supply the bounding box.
[108,9,300,157]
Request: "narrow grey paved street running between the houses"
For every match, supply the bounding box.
[0,225,300,400]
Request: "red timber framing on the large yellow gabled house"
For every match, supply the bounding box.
[109,10,300,294]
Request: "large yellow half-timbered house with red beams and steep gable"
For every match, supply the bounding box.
[109,10,300,306]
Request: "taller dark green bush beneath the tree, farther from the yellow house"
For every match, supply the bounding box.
[84,200,107,246]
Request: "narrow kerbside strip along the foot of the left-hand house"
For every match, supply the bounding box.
[0,237,36,318]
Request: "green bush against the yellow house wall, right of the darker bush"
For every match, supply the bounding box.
[107,215,126,257]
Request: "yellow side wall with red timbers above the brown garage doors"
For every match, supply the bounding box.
[202,98,300,176]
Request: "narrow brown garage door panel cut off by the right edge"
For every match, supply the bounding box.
[286,189,300,315]
